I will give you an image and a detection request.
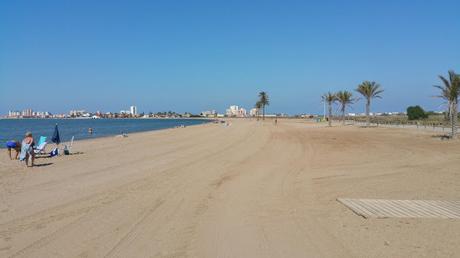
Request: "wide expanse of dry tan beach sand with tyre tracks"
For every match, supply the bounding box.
[0,120,460,257]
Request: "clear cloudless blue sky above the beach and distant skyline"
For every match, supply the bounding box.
[0,0,460,114]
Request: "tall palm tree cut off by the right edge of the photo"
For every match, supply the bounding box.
[434,70,460,138]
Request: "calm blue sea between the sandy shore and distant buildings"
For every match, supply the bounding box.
[0,119,209,148]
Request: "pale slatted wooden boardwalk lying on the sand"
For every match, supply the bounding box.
[337,198,460,219]
